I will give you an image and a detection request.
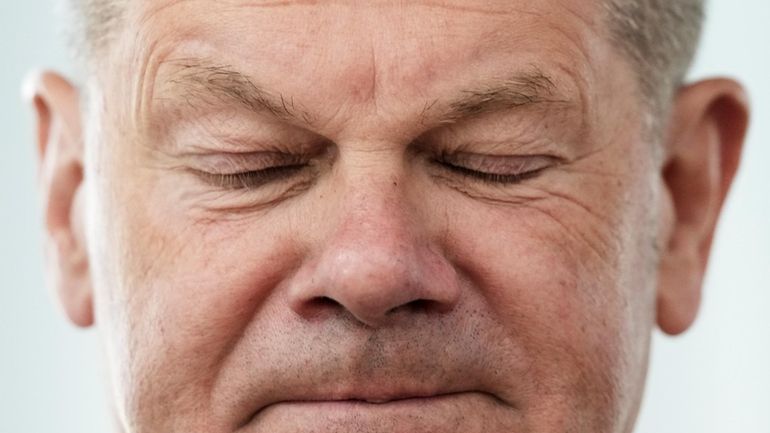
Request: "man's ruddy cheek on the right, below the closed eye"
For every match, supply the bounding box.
[440,163,654,413]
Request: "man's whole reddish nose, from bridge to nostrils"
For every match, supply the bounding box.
[289,178,460,327]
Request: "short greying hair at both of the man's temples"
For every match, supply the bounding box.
[66,0,705,111]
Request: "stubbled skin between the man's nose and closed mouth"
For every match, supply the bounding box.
[212,312,529,427]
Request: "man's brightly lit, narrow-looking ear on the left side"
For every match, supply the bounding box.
[25,72,94,327]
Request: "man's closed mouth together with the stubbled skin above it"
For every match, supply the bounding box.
[219,310,530,432]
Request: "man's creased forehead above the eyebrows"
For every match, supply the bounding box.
[116,0,607,135]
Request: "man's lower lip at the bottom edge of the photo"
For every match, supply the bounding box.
[246,392,512,433]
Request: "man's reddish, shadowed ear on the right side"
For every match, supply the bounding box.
[657,79,749,335]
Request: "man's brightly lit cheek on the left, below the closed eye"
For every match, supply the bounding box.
[92,150,304,431]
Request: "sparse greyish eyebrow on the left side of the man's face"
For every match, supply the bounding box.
[159,59,313,124]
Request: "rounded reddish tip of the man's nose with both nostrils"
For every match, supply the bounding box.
[290,239,460,327]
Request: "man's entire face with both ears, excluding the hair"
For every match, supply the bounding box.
[32,0,748,433]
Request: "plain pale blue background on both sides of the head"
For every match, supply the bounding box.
[0,0,770,433]
